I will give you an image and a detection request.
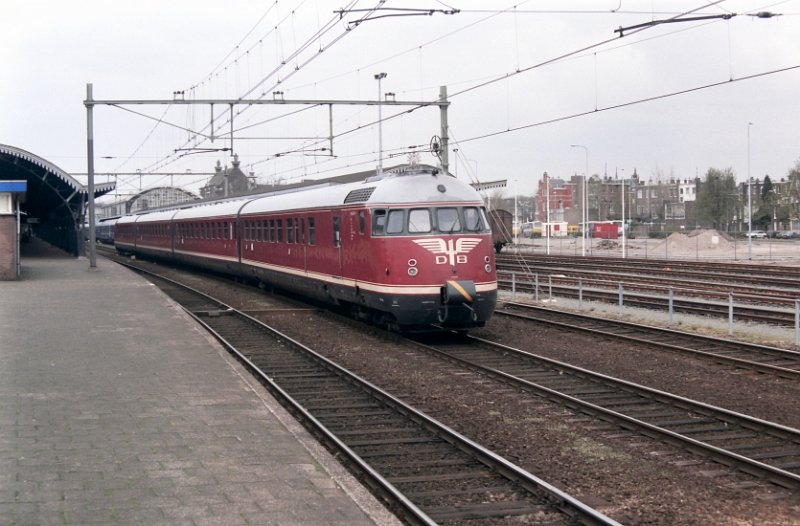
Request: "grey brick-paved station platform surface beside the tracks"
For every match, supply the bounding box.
[0,240,398,526]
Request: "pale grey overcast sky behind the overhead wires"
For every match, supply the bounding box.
[0,0,800,200]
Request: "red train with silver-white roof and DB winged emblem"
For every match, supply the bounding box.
[115,165,497,331]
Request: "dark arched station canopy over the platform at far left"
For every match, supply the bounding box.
[0,144,116,256]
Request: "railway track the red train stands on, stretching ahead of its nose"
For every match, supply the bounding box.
[412,336,800,489]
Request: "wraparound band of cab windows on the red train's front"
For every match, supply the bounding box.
[372,206,489,236]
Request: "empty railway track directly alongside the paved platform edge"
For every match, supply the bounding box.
[123,269,618,525]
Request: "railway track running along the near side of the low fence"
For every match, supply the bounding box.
[495,302,800,380]
